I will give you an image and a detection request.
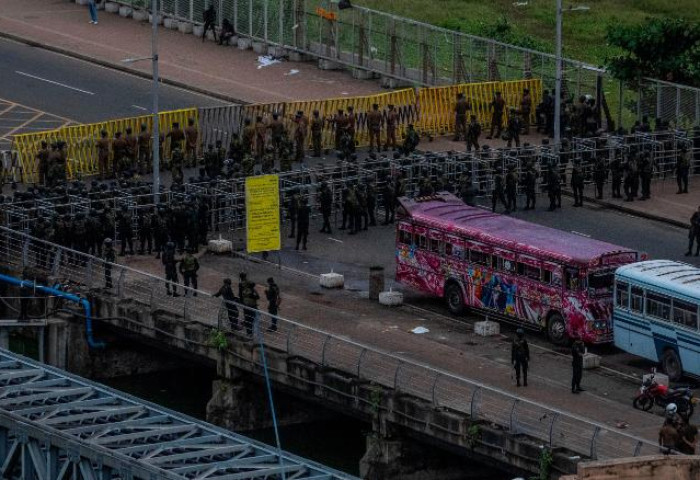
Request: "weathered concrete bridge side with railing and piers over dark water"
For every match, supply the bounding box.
[0,229,657,478]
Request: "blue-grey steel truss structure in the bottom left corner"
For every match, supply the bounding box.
[0,350,354,480]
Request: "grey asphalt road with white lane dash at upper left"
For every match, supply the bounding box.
[0,39,224,123]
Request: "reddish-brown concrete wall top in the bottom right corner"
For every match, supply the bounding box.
[560,455,700,480]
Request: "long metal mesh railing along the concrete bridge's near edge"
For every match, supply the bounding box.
[0,227,658,459]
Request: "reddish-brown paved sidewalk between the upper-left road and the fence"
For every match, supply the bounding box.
[0,0,382,103]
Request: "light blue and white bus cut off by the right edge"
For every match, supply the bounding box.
[612,260,700,381]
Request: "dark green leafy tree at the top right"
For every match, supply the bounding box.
[606,18,700,86]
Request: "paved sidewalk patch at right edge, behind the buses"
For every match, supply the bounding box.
[584,177,700,227]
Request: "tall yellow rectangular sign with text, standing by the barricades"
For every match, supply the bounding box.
[245,175,282,253]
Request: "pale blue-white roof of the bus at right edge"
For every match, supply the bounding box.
[615,260,700,298]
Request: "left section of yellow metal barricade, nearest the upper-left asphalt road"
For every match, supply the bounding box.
[12,108,199,183]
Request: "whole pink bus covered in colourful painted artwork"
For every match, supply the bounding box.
[396,193,640,344]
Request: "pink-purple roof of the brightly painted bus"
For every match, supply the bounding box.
[399,192,637,266]
